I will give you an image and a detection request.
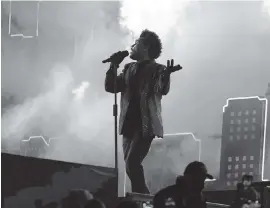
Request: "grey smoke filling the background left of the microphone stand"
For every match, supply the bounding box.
[2,2,125,166]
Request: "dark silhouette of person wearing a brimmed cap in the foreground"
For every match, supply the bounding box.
[153,161,213,208]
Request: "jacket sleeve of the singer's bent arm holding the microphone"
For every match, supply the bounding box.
[105,64,130,93]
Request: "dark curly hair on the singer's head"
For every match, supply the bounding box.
[140,29,162,59]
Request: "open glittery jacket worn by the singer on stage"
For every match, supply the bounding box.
[105,61,170,137]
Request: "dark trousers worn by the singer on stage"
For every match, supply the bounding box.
[123,130,153,194]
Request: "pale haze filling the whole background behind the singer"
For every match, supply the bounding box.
[2,0,270,179]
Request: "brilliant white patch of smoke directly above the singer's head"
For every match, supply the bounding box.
[120,0,189,40]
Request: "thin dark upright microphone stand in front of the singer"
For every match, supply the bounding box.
[110,63,119,196]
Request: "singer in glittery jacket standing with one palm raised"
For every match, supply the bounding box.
[105,30,182,194]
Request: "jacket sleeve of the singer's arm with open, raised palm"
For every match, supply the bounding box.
[155,65,171,95]
